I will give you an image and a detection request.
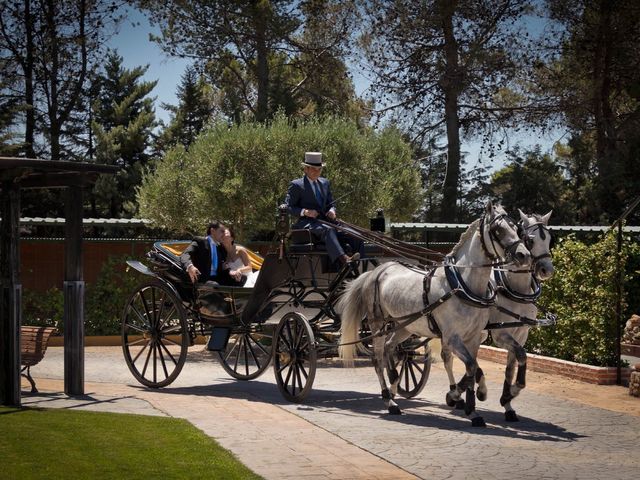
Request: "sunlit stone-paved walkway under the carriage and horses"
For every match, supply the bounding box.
[15,346,640,480]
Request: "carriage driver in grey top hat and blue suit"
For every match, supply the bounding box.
[285,152,364,265]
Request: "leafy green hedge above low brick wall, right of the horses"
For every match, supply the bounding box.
[527,233,640,366]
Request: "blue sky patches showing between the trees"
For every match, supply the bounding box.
[108,8,562,174]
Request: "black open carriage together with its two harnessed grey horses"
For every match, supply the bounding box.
[122,202,553,425]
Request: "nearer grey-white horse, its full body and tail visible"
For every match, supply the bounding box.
[337,202,531,426]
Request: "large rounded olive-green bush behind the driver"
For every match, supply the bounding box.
[138,115,422,239]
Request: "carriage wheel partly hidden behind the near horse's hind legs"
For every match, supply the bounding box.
[397,339,431,398]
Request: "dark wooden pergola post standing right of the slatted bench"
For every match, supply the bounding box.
[63,185,84,395]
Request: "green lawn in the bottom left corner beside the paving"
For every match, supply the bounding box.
[0,407,261,480]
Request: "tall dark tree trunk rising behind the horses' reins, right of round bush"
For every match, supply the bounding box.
[439,0,462,222]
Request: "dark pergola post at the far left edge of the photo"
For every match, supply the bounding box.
[0,181,22,407]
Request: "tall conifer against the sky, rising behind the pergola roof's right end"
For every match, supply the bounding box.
[92,51,157,218]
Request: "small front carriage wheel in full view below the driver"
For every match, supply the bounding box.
[273,312,317,402]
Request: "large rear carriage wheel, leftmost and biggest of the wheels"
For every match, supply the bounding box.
[122,282,190,388]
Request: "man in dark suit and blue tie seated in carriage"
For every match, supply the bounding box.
[180,221,244,286]
